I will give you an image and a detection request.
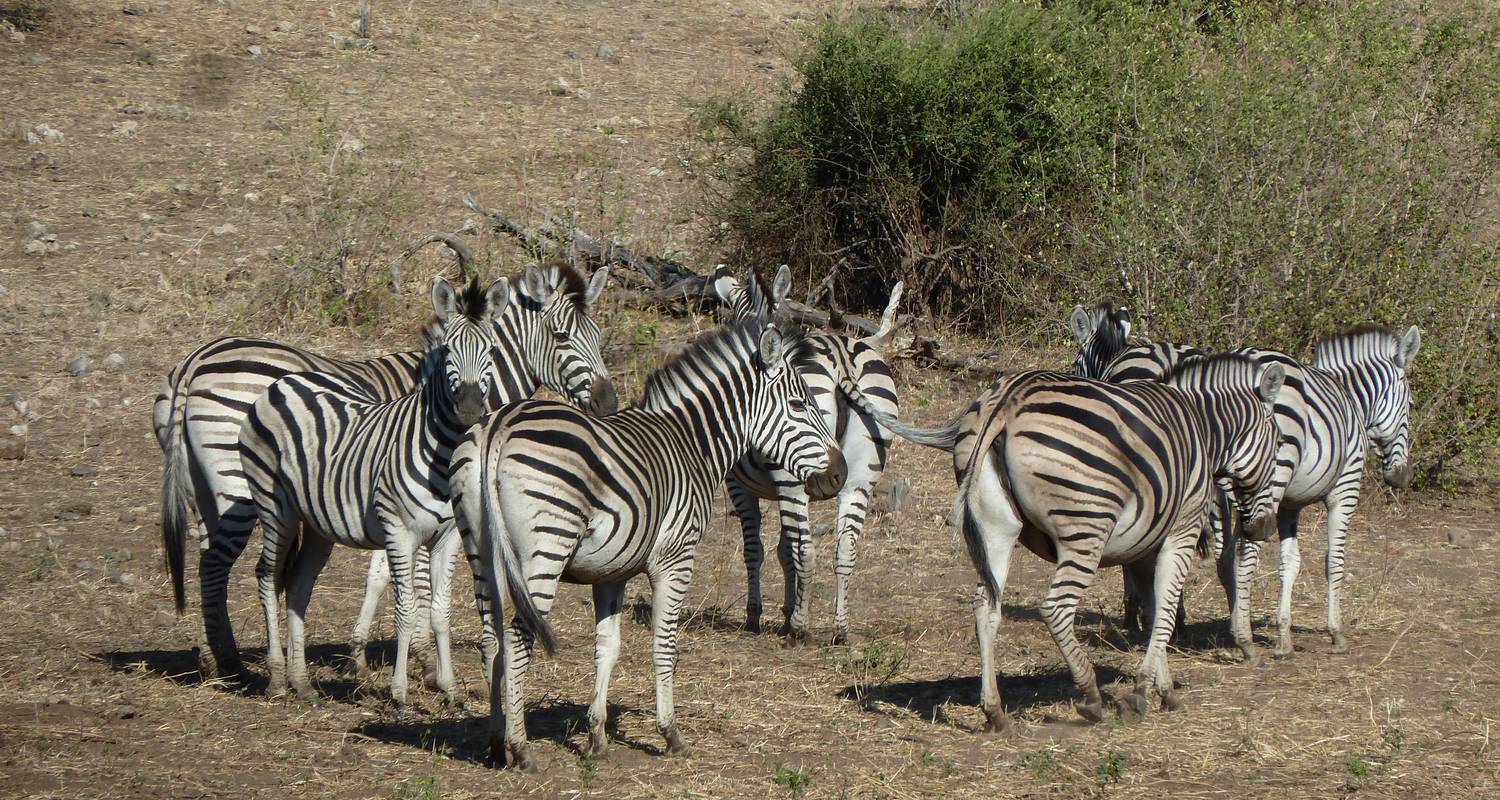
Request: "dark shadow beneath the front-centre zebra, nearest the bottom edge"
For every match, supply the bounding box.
[353,699,663,767]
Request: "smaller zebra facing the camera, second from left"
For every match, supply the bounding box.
[240,276,510,707]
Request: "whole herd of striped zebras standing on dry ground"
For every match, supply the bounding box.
[153,234,1421,768]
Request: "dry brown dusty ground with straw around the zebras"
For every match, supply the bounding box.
[0,0,1500,798]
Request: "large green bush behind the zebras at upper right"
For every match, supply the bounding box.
[711,0,1500,479]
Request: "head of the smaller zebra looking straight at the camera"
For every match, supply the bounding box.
[432,275,510,428]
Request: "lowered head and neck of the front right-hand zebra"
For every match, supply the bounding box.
[1167,353,1286,542]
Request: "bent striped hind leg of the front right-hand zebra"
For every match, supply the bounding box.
[1041,540,1104,722]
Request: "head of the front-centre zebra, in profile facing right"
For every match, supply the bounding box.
[749,323,849,500]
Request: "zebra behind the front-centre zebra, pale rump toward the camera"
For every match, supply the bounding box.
[713,266,902,644]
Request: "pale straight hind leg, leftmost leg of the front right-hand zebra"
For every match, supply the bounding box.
[960,458,1022,732]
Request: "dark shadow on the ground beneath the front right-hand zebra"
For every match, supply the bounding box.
[837,665,1128,728]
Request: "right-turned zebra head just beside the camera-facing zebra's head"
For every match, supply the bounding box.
[518,264,620,414]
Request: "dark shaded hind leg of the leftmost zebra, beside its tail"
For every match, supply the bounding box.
[198,500,257,678]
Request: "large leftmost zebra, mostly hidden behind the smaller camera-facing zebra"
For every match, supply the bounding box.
[153,234,615,678]
